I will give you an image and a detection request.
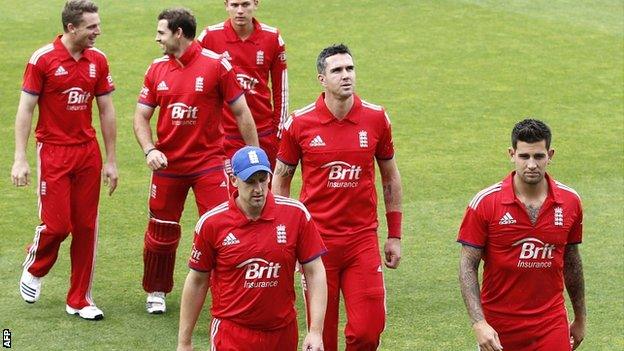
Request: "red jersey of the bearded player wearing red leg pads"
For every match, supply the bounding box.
[139,42,243,175]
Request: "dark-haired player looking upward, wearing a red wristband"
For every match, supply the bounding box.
[273,45,402,351]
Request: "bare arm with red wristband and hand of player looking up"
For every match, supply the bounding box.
[377,158,403,269]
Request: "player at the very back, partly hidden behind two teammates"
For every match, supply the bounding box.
[197,0,288,166]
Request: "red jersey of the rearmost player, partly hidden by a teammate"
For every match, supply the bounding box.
[197,18,288,138]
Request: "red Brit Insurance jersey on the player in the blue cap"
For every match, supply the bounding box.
[189,193,326,330]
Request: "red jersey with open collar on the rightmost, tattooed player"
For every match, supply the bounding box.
[457,172,583,317]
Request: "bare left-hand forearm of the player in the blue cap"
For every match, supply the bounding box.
[178,272,209,345]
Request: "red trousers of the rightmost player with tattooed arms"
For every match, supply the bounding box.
[485,311,572,351]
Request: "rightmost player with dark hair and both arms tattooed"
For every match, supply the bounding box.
[457,119,587,351]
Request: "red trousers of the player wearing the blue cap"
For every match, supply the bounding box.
[210,318,299,351]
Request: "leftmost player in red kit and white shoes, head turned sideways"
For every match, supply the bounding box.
[11,0,118,320]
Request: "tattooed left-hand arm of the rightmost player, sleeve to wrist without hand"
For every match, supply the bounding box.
[459,245,485,324]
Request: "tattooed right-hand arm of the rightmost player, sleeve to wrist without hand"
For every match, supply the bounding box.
[563,245,587,317]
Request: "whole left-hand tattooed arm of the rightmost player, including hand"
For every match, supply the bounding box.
[459,245,503,351]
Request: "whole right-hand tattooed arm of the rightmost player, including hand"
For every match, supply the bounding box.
[563,245,587,350]
